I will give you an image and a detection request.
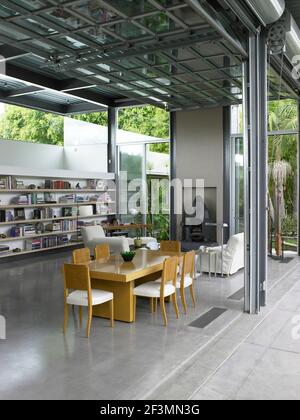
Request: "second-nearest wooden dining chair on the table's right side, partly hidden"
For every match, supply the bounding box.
[176,251,196,314]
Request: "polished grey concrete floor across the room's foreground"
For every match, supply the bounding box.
[0,249,300,399]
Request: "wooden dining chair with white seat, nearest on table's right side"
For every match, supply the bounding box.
[134,257,179,326]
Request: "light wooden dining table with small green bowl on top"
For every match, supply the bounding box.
[89,249,183,322]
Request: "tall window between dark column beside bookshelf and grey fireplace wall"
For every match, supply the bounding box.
[117,106,170,240]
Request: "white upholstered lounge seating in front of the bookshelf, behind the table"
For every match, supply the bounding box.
[81,226,130,255]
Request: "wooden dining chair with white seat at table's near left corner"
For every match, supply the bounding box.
[64,264,114,337]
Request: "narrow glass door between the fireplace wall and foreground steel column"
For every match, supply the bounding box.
[231,137,245,235]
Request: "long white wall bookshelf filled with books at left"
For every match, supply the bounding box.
[0,166,116,260]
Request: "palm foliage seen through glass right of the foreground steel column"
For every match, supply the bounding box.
[269,100,298,256]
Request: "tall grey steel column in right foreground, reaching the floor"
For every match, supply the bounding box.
[244,33,268,314]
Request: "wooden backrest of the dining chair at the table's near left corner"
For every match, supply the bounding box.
[64,264,91,293]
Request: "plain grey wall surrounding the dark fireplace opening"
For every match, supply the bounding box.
[176,108,223,239]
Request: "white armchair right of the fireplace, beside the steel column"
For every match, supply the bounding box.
[197,233,245,276]
